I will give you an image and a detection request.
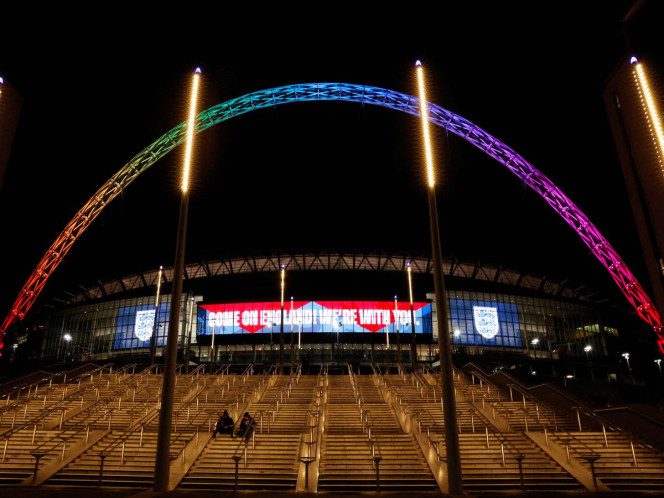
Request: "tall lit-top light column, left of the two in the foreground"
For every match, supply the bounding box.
[154,68,201,491]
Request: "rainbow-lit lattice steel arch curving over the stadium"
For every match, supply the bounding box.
[0,83,664,353]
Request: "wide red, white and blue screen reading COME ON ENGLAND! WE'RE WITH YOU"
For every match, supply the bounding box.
[198,301,431,335]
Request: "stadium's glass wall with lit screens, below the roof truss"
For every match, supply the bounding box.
[42,290,618,363]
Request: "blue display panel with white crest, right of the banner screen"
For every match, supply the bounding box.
[449,299,522,348]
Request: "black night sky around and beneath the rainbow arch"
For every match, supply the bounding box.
[0,1,664,322]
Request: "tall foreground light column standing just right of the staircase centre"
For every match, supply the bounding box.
[415,61,463,495]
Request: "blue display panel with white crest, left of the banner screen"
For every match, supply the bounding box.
[113,302,170,350]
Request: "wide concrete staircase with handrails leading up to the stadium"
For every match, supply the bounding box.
[0,372,664,493]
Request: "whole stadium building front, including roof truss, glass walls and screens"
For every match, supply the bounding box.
[41,253,618,364]
